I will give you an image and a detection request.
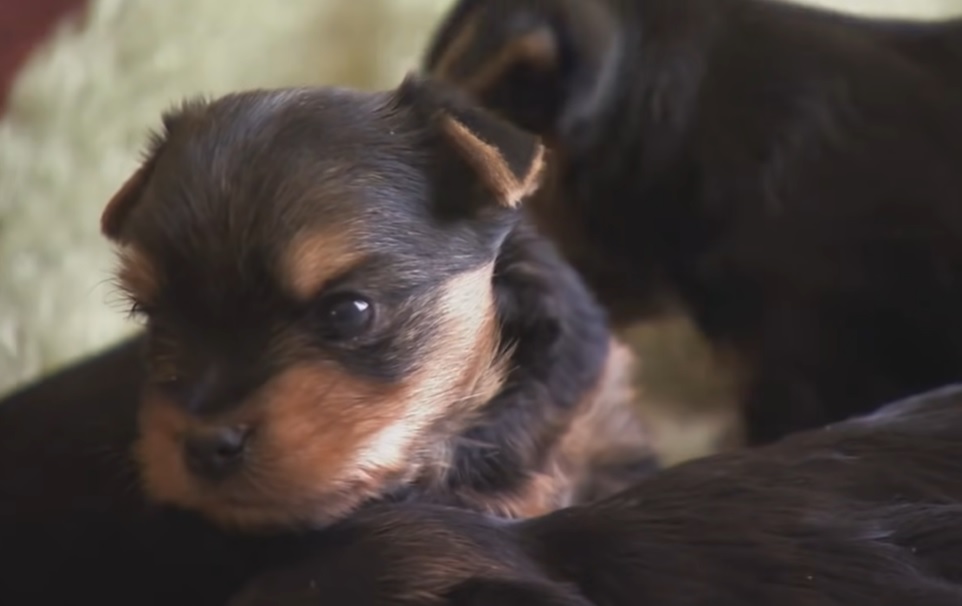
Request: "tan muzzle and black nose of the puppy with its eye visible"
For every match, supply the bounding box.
[135,369,438,533]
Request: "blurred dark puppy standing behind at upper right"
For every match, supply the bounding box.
[425,0,962,443]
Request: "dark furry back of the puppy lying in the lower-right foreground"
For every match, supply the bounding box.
[523,385,962,606]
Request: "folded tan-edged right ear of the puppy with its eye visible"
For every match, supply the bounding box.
[398,75,545,209]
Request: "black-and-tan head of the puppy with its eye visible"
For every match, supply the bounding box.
[102,77,542,530]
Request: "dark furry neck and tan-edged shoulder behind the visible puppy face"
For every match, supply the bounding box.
[410,224,652,517]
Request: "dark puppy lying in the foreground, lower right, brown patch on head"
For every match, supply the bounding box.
[231,386,962,606]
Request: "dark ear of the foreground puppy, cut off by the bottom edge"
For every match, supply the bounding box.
[443,579,591,606]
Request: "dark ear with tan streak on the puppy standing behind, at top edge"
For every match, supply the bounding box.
[423,0,622,144]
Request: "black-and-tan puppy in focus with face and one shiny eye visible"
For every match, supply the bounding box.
[102,77,653,532]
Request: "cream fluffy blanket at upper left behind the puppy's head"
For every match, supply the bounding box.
[0,0,448,392]
